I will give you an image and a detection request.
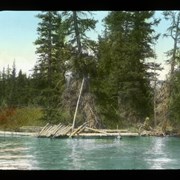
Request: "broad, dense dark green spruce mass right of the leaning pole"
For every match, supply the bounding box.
[96,11,159,128]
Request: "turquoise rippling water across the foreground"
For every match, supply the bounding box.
[0,136,180,170]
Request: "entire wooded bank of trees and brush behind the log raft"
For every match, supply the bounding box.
[0,11,180,134]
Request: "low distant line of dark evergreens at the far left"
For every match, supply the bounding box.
[0,62,31,107]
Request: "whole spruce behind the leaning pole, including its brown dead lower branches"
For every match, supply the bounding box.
[62,11,101,127]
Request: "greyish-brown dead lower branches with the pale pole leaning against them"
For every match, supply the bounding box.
[59,74,102,129]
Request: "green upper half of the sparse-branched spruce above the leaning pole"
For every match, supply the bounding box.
[62,11,97,77]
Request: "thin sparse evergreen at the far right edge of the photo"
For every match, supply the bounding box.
[163,11,180,130]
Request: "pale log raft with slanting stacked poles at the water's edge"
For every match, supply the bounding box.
[37,123,139,138]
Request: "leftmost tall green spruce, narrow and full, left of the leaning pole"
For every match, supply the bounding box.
[33,11,64,122]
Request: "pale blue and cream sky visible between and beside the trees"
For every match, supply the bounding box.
[0,11,173,79]
